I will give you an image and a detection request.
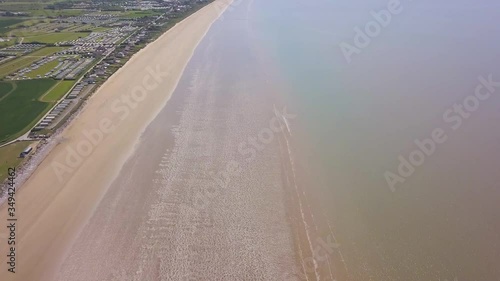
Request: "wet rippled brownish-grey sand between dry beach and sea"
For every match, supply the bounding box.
[50,2,302,276]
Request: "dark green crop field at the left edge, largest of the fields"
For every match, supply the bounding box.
[0,79,57,143]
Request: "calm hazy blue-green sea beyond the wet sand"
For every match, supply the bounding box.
[225,0,500,281]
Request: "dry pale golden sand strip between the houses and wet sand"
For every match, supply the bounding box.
[0,1,234,281]
